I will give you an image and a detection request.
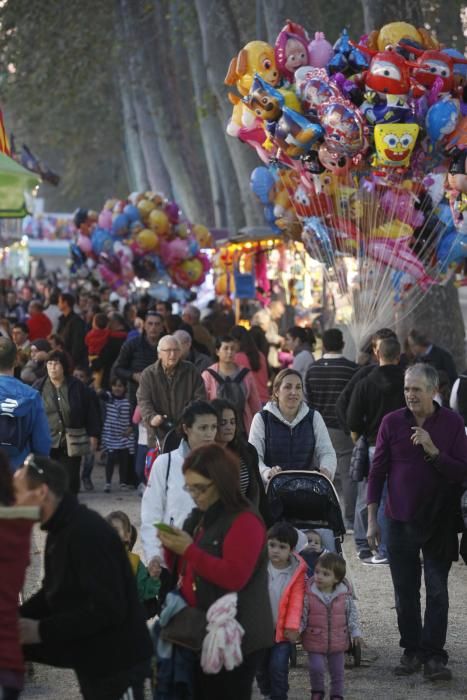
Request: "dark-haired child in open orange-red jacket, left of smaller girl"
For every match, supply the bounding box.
[256,522,307,700]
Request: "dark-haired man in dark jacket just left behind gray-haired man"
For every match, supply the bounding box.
[115,311,165,408]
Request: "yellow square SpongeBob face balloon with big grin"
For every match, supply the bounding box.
[374,124,420,168]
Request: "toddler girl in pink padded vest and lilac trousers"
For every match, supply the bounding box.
[302,552,362,700]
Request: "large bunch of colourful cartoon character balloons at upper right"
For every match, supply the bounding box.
[225,20,467,322]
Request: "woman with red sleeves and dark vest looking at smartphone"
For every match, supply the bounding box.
[159,444,274,700]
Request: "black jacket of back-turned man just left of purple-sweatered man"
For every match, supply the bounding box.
[347,365,405,445]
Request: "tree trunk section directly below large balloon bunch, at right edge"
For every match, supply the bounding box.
[396,281,465,372]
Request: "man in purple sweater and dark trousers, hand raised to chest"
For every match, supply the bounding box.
[367,363,467,681]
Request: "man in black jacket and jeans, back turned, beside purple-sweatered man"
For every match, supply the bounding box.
[347,338,405,564]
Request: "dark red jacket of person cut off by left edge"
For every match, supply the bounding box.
[0,508,33,673]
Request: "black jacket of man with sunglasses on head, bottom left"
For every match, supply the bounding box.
[20,494,152,678]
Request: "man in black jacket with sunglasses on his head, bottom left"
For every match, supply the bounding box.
[15,455,152,700]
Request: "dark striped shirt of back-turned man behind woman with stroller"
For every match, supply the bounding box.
[305,355,358,428]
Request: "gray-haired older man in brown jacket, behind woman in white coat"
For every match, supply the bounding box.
[136,335,206,447]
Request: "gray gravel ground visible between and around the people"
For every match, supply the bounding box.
[22,468,467,700]
